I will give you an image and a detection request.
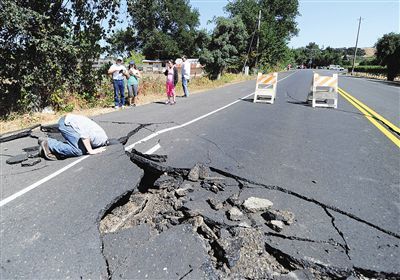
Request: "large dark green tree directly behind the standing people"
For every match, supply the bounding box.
[127,0,203,59]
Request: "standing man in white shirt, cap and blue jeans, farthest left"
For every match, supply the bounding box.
[108,56,129,109]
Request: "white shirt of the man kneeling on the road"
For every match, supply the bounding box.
[64,114,108,148]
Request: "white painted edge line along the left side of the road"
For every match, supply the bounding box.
[0,70,299,207]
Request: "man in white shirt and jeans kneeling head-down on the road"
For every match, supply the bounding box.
[39,114,108,160]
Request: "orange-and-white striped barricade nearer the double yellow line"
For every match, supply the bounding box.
[311,73,338,109]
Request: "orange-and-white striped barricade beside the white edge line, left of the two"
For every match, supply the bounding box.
[253,72,278,104]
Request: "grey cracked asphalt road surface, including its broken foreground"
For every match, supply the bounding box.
[0,70,400,279]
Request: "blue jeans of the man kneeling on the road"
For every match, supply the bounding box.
[48,117,86,157]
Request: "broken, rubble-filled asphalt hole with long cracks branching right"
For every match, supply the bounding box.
[95,145,400,279]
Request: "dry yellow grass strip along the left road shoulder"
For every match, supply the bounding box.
[0,75,254,134]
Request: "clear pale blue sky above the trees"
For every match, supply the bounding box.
[190,0,400,48]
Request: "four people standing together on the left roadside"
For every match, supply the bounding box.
[108,56,190,109]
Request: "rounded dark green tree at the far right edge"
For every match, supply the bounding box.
[376,32,400,81]
